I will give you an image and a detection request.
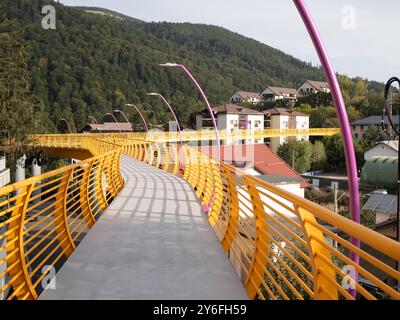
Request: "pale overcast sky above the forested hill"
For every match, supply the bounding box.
[60,0,400,82]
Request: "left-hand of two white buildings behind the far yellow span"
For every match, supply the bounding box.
[196,104,264,145]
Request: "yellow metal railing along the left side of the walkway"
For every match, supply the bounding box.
[0,144,124,299]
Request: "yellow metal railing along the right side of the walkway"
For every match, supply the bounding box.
[121,140,400,300]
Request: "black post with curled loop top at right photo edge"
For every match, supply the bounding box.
[381,77,400,282]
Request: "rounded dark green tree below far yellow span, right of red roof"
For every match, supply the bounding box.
[278,141,313,173]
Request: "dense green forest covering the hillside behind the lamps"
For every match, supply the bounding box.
[0,0,388,132]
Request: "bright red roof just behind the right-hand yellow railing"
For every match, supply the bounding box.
[201,144,309,188]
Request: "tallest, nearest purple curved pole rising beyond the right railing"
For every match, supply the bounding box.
[293,0,360,296]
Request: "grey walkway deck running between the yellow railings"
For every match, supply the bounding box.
[40,157,248,300]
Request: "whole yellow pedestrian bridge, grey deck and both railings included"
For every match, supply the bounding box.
[0,133,400,300]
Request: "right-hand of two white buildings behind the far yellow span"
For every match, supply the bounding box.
[264,108,310,152]
